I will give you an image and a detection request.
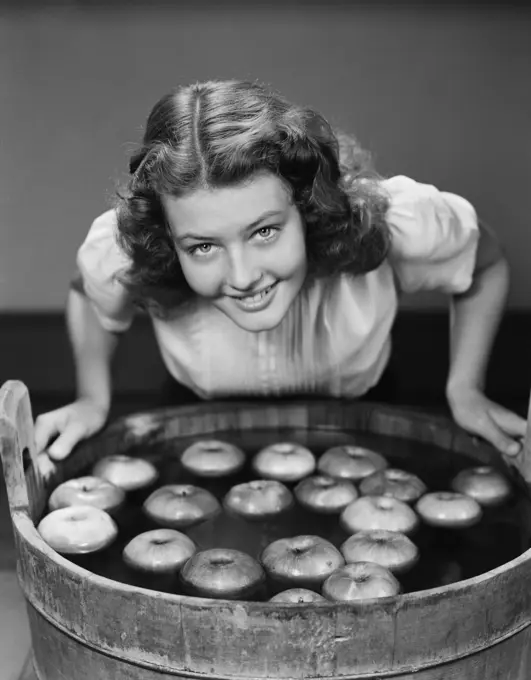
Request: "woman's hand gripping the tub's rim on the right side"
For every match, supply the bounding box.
[448,388,526,456]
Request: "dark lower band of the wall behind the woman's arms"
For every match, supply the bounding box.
[0,310,531,414]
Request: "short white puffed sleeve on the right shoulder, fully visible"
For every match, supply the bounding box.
[383,176,479,293]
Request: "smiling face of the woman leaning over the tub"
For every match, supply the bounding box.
[162,173,307,332]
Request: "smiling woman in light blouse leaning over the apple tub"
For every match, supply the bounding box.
[36,81,525,458]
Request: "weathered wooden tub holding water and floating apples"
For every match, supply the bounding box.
[0,382,531,680]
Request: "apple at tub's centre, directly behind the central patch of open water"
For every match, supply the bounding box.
[223,479,293,520]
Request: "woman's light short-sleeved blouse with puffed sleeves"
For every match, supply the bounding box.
[77,176,479,399]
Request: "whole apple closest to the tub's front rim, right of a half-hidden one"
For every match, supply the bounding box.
[322,562,400,602]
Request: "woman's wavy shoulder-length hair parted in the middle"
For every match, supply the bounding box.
[116,80,390,316]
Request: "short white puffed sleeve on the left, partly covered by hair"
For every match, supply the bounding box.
[76,210,135,332]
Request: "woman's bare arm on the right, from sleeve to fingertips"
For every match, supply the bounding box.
[446,223,525,455]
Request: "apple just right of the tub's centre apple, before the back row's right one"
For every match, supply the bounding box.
[294,475,358,515]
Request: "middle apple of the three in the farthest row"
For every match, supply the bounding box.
[253,442,315,482]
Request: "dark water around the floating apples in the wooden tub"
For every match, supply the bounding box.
[55,429,531,599]
